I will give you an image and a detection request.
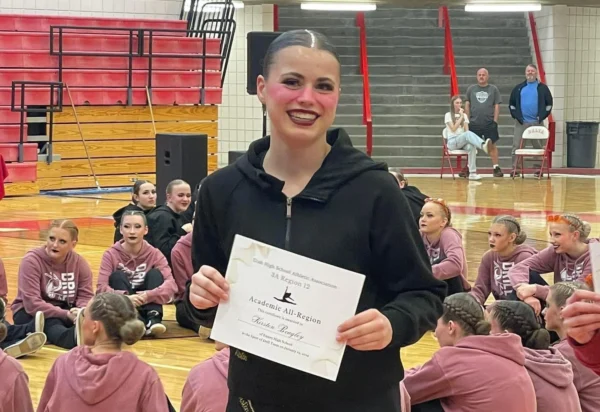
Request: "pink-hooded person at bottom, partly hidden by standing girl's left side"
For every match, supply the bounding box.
[180,342,229,412]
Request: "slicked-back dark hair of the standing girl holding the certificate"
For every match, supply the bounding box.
[263,29,340,79]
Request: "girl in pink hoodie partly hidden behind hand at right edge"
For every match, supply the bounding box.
[544,282,600,412]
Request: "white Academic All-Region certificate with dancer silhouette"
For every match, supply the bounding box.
[211,235,365,381]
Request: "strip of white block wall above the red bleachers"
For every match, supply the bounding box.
[0,0,183,19]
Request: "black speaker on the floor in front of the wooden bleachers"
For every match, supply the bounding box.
[156,133,208,205]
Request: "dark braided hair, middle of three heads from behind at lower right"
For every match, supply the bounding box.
[490,300,550,349]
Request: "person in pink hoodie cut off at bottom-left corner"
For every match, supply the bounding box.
[0,323,33,412]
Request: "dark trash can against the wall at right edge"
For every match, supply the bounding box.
[567,122,600,168]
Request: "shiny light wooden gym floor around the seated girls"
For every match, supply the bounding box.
[0,176,600,409]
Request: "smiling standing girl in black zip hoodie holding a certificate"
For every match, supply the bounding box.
[184,30,445,412]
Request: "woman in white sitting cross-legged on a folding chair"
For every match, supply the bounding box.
[444,96,491,180]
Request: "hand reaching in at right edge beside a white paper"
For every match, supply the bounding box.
[561,290,600,345]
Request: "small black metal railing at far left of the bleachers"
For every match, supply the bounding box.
[10,80,64,164]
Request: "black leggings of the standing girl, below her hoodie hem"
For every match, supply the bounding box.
[226,387,400,412]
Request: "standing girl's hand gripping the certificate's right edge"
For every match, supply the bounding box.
[337,309,392,351]
